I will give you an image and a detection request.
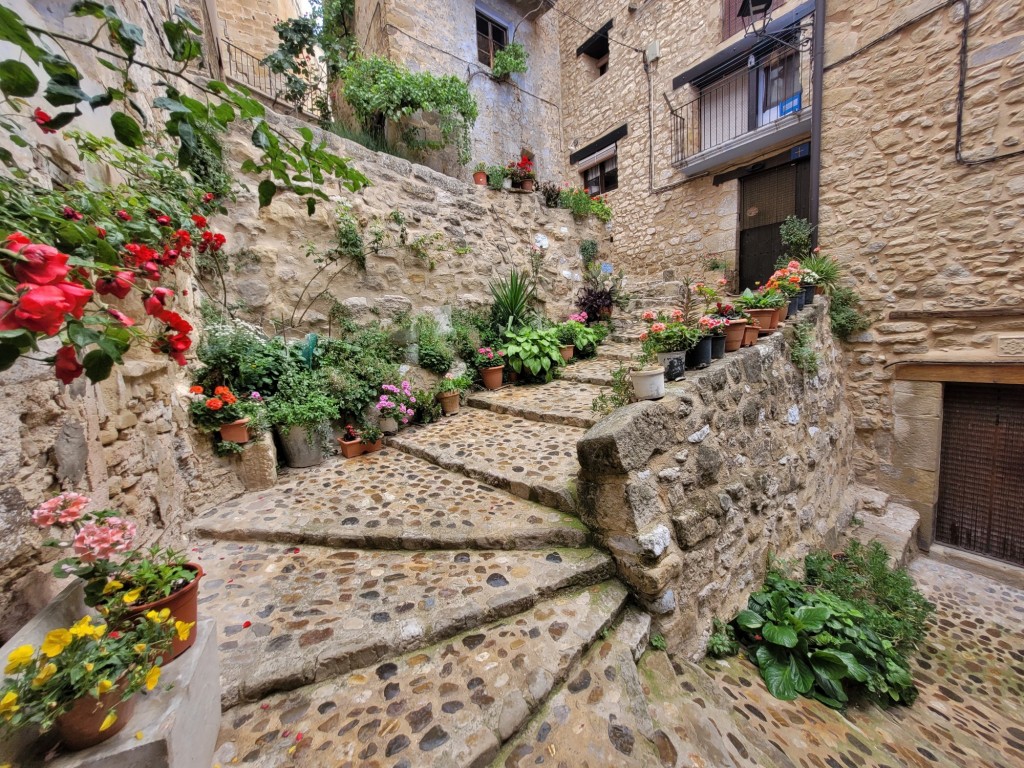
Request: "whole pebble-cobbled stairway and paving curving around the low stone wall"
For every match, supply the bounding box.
[186,332,1024,768]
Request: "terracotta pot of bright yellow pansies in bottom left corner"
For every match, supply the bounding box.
[0,613,178,750]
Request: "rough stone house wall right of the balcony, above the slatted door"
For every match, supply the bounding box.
[821,0,1024,518]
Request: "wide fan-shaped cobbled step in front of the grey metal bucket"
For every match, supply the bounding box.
[193,447,589,550]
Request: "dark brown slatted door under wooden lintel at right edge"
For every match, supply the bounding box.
[935,384,1024,565]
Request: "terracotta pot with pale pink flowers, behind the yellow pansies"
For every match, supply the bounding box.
[32,493,203,662]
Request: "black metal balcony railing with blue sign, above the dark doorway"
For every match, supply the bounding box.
[671,38,811,165]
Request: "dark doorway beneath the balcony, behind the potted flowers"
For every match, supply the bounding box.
[739,160,811,290]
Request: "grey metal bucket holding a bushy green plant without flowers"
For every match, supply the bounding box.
[266,369,338,469]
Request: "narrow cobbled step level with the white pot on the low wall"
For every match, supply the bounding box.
[466,380,601,429]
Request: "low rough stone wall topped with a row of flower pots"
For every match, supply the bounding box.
[579,301,855,656]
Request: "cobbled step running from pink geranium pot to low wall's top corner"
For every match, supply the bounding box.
[387,409,586,513]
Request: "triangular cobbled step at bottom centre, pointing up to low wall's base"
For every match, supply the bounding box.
[492,623,678,768]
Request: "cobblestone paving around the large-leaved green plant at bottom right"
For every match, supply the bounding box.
[707,558,1024,768]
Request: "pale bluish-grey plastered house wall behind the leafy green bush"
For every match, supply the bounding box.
[356,0,561,179]
